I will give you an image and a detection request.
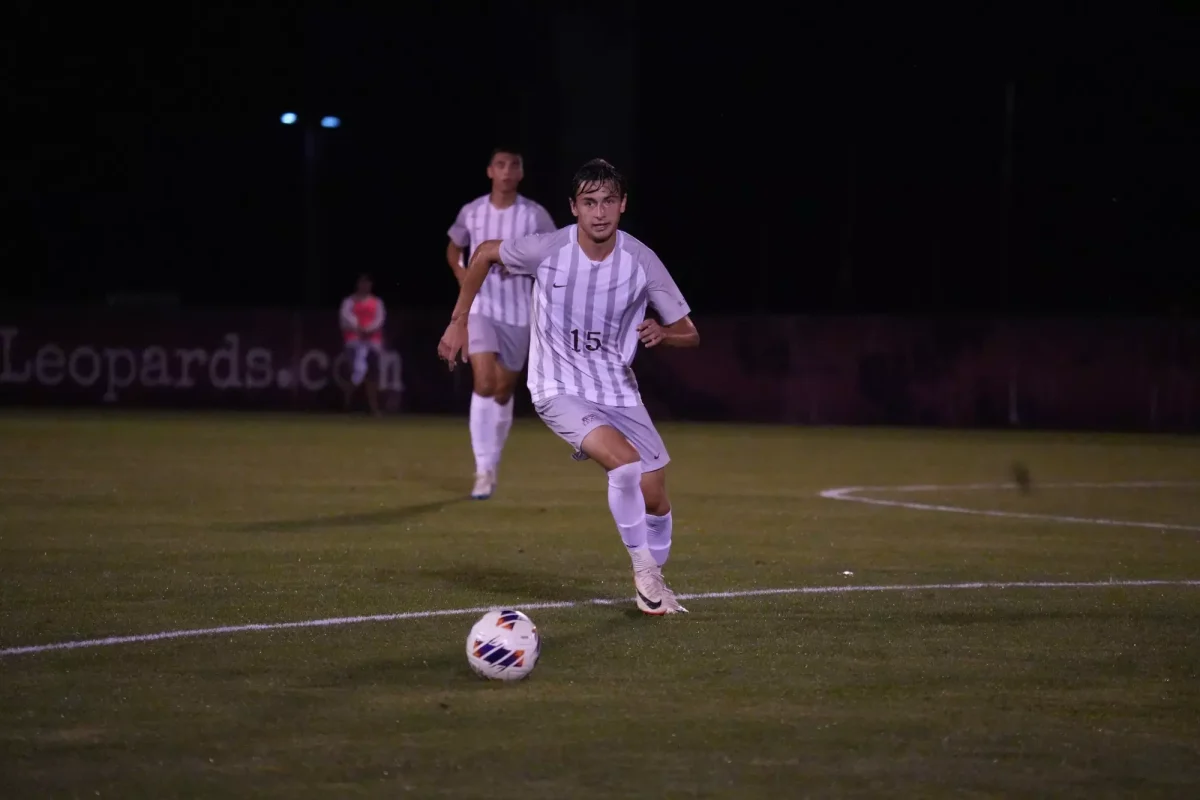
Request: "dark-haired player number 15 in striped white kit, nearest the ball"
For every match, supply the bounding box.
[438,158,700,615]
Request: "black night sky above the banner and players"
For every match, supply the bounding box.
[0,0,1200,314]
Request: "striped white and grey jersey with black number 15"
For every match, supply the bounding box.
[500,225,691,408]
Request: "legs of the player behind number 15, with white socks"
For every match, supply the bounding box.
[470,353,517,500]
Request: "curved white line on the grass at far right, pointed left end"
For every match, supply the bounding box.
[821,481,1200,531]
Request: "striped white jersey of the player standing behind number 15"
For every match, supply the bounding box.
[448,194,554,326]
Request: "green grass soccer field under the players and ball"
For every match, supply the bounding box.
[0,414,1200,800]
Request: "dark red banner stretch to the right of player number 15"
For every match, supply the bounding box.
[638,317,1200,431]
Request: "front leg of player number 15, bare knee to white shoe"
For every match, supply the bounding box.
[580,425,686,616]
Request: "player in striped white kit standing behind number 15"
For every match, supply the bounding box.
[446,148,556,500]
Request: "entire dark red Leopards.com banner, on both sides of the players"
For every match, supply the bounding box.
[0,309,1200,431]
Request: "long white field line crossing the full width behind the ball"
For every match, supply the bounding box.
[0,581,1200,656]
